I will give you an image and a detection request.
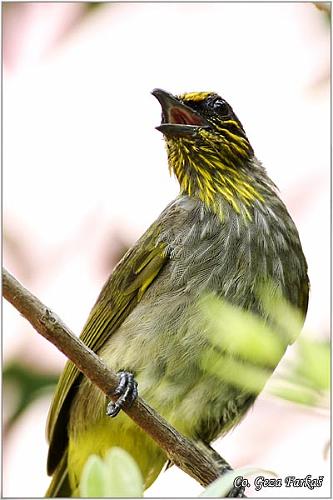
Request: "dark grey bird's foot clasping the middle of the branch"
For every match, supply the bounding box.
[106,371,138,418]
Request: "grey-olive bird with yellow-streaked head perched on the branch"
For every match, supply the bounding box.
[47,89,309,496]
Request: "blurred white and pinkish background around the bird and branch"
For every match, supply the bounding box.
[2,2,330,497]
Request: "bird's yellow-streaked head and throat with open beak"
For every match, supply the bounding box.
[152,89,263,219]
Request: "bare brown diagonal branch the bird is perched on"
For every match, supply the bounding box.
[3,270,236,486]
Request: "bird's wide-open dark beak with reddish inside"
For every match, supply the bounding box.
[152,89,208,137]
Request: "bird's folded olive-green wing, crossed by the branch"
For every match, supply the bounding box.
[47,229,168,474]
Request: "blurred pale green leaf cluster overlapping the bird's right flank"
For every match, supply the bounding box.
[200,292,330,407]
